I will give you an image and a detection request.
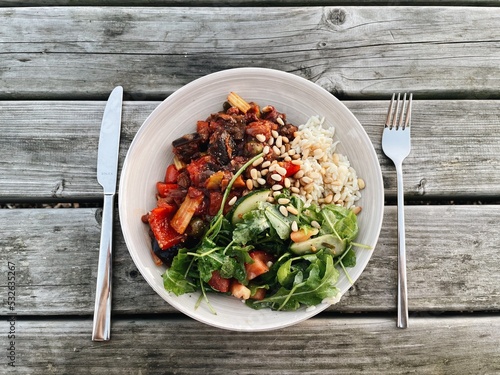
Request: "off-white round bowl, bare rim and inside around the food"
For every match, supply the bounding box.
[119,68,384,331]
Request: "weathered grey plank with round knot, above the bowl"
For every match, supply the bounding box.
[0,6,500,100]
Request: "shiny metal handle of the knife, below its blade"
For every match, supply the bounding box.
[92,194,115,341]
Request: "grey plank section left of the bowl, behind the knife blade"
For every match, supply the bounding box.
[0,102,158,202]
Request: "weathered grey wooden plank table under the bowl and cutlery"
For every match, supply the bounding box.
[0,0,500,375]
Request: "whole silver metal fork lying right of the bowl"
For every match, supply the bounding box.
[382,93,413,328]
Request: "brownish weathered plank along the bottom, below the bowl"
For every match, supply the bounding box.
[9,316,500,375]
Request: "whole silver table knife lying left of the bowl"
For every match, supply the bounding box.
[92,86,123,341]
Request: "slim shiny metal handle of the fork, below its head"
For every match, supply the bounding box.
[396,164,408,328]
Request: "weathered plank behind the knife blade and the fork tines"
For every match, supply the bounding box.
[0,97,500,202]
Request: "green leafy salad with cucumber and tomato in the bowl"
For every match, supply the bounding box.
[163,155,366,311]
